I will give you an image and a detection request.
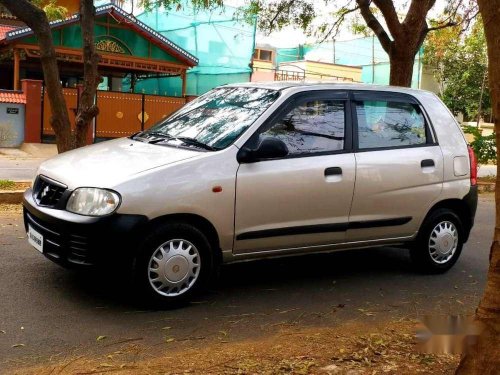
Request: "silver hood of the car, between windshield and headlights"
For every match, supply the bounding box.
[38,138,204,189]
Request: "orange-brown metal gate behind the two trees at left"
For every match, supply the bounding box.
[42,88,191,139]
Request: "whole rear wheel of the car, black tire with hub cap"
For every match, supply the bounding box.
[410,208,464,273]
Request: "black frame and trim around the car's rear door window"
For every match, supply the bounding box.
[350,90,438,153]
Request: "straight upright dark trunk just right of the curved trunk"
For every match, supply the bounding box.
[72,0,101,148]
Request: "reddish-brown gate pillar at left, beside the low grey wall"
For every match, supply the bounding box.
[21,79,42,143]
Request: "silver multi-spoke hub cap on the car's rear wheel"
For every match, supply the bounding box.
[429,221,458,264]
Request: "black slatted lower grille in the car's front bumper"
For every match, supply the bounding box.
[24,209,94,265]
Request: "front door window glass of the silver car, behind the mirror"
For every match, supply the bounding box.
[259,99,345,155]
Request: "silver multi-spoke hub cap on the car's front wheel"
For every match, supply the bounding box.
[148,239,200,297]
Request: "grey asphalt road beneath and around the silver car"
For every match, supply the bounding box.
[0,196,494,372]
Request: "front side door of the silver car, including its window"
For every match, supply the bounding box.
[234,91,355,254]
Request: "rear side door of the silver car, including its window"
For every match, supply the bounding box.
[347,91,443,241]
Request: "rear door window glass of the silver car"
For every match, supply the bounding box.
[356,101,427,149]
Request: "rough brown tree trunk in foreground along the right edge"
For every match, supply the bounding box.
[457,0,500,375]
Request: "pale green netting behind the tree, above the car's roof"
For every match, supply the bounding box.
[276,37,423,88]
